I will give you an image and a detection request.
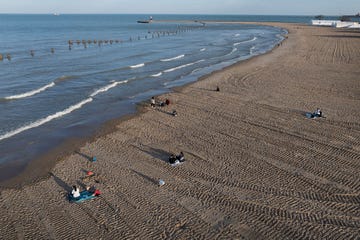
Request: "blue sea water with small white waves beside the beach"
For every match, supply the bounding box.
[0,14,304,180]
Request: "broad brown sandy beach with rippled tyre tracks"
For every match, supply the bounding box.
[0,23,360,239]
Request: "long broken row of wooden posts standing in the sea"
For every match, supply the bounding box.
[0,24,205,61]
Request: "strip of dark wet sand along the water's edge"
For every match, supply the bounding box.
[0,20,290,188]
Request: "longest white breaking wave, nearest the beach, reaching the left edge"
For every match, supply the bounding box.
[0,98,93,141]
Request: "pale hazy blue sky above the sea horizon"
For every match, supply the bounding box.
[0,0,360,15]
